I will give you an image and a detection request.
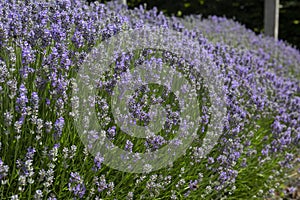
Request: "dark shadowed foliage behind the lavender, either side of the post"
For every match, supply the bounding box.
[92,0,300,49]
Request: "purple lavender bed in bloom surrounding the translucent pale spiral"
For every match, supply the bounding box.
[0,0,300,199]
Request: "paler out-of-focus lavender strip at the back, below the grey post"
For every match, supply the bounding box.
[181,16,300,78]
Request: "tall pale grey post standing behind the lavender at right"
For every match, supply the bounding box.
[264,0,279,40]
